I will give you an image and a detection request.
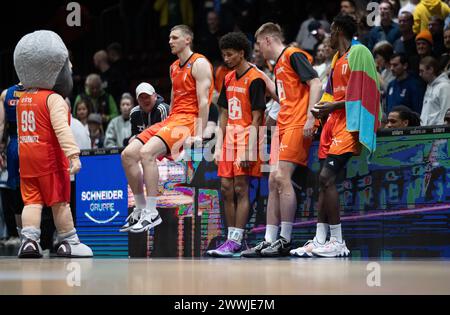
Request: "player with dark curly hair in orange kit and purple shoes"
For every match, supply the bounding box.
[207,32,266,257]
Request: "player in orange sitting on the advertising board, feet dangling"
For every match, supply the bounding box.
[121,25,214,233]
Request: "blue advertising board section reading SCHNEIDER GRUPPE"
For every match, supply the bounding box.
[75,152,128,256]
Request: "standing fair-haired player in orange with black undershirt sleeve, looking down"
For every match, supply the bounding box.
[242,23,321,257]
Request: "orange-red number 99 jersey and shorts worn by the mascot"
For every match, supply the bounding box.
[17,90,70,206]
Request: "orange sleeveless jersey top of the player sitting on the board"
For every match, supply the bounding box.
[170,53,214,116]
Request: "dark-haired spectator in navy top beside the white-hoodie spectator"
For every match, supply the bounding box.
[386,54,425,113]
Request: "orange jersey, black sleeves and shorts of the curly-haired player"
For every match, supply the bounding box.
[218,66,266,178]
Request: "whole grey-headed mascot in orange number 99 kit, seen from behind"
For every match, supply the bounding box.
[14,31,93,258]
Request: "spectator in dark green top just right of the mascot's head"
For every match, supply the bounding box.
[73,74,119,126]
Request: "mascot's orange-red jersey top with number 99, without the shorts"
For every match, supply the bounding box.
[17,89,70,178]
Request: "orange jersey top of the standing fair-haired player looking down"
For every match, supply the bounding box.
[274,47,313,132]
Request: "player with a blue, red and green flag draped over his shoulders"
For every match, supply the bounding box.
[291,14,380,257]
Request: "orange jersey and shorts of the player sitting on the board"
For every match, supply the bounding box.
[137,54,214,155]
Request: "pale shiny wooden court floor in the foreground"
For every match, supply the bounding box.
[0,257,450,295]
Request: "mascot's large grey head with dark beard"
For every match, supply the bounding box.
[14,31,73,97]
